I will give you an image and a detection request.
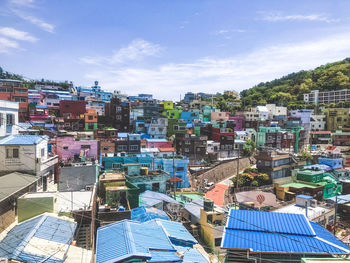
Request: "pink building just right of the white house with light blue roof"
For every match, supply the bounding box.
[56,136,98,161]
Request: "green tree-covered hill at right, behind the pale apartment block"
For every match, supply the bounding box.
[241,58,350,108]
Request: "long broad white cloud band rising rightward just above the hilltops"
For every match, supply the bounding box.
[81,33,350,100]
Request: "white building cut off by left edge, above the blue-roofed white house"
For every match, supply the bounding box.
[0,100,19,137]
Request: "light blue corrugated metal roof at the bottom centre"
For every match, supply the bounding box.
[95,219,209,263]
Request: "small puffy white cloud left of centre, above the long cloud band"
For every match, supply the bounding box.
[80,39,162,65]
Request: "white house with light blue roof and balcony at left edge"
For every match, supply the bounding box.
[0,135,58,191]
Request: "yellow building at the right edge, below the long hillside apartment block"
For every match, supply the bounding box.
[324,108,350,132]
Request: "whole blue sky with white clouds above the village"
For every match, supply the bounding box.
[0,0,350,100]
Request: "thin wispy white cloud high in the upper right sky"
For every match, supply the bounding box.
[261,12,339,23]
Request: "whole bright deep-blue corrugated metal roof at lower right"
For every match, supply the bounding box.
[221,210,350,254]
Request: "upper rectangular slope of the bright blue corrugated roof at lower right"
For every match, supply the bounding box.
[227,209,315,236]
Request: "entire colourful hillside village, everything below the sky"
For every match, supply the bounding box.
[0,60,350,263]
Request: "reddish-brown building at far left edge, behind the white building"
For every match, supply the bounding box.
[0,79,29,122]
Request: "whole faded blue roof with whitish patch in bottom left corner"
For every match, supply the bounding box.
[0,214,76,263]
